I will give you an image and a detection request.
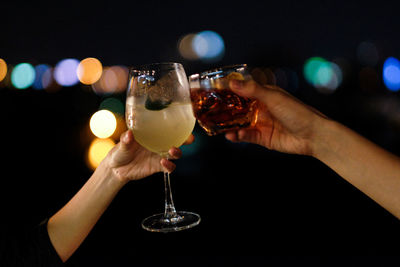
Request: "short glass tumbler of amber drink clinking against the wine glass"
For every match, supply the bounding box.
[189,65,258,135]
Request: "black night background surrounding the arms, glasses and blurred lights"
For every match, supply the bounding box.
[0,0,400,266]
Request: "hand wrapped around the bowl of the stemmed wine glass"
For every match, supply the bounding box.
[104,130,194,182]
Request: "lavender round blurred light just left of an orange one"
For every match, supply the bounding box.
[54,58,79,86]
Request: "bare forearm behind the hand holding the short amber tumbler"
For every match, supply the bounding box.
[313,119,400,218]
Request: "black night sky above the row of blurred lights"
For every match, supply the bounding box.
[4,0,399,68]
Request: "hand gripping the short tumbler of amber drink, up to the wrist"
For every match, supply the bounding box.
[225,80,326,155]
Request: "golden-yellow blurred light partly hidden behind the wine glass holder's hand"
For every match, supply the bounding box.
[87,138,115,169]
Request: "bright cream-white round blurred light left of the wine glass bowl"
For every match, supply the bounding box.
[90,109,117,138]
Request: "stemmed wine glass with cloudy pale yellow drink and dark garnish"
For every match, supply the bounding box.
[126,63,200,232]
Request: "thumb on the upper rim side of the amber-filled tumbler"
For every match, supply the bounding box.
[229,79,268,104]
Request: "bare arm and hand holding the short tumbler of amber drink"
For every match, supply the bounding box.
[226,81,400,219]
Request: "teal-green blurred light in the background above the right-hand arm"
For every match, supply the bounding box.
[303,57,342,93]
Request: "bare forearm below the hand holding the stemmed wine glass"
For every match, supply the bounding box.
[47,160,124,262]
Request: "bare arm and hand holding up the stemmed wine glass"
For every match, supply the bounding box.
[47,131,186,262]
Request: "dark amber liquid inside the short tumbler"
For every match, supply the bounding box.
[190,88,258,135]
